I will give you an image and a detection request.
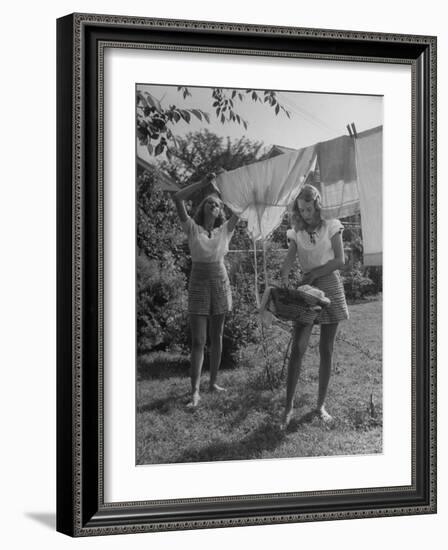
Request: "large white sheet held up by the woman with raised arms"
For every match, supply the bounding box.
[216,146,314,240]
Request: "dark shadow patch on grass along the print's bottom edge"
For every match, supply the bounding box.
[176,422,285,462]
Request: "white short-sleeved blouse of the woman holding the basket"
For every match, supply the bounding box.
[286,219,344,273]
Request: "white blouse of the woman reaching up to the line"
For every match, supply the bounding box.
[182,217,233,263]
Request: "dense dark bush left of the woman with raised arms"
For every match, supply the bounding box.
[136,166,188,353]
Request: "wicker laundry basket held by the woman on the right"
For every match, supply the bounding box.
[266,286,330,325]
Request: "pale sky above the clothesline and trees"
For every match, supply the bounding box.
[137,84,383,160]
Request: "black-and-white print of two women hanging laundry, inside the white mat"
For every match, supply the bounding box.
[135,83,384,465]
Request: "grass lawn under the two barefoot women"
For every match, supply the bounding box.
[136,300,382,464]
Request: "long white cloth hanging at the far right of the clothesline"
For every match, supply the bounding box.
[355,126,383,265]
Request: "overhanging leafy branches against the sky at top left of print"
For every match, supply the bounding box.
[136,86,290,158]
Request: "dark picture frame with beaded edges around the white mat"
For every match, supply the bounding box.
[57,14,436,536]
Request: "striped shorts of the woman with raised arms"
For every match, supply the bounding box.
[188,262,232,316]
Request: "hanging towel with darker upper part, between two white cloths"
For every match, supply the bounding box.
[316,136,359,219]
